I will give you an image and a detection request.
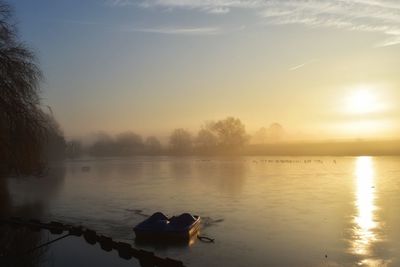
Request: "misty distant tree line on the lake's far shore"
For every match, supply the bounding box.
[66,117,283,158]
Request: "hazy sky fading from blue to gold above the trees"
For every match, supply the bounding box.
[9,0,400,139]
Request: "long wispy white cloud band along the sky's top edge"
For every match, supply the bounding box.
[108,0,400,46]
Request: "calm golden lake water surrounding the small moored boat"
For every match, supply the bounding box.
[4,157,400,266]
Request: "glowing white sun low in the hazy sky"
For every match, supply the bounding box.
[347,85,380,114]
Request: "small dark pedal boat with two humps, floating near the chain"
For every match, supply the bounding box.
[133,212,200,241]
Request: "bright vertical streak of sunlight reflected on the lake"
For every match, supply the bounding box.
[352,157,378,266]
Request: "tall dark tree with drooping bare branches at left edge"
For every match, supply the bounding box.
[0,1,47,176]
